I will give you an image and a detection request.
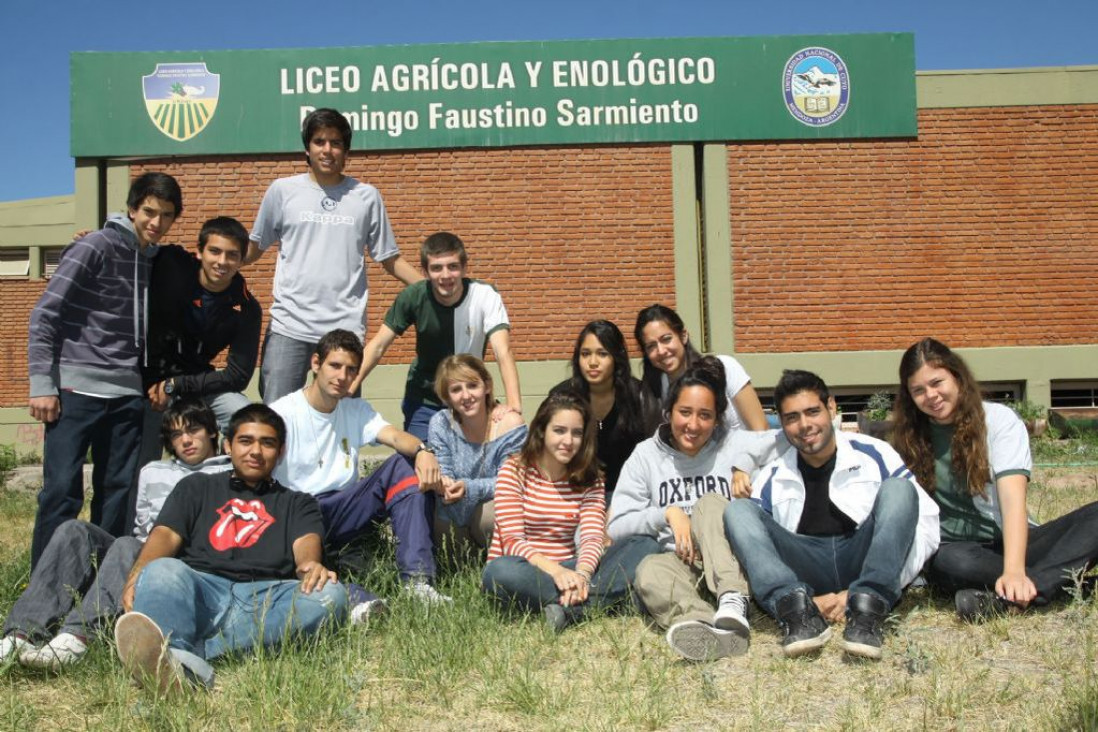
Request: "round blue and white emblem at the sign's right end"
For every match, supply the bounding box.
[782,47,850,127]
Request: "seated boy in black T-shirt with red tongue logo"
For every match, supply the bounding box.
[114,404,347,692]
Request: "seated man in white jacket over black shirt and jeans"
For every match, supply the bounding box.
[725,371,938,660]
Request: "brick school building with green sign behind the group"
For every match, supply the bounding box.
[0,34,1098,458]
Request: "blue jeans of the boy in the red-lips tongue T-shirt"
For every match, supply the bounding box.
[133,558,347,676]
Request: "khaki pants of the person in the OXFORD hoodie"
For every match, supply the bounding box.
[634,493,748,628]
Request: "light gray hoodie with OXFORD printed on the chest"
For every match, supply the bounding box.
[608,425,789,551]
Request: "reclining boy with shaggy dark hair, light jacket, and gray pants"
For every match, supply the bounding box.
[0,399,229,671]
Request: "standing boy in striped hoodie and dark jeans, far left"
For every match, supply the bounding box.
[27,172,183,567]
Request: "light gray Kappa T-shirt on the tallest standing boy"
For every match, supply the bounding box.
[250,173,400,342]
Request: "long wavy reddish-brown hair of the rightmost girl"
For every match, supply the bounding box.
[893,338,990,496]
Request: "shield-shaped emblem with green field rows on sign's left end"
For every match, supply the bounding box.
[142,61,221,143]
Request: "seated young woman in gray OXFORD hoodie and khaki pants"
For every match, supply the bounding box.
[609,357,787,661]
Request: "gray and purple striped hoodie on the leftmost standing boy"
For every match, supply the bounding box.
[26,214,157,397]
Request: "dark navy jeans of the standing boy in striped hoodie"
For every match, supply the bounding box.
[31,391,144,570]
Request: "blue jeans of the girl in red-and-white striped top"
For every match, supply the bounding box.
[481,536,660,611]
